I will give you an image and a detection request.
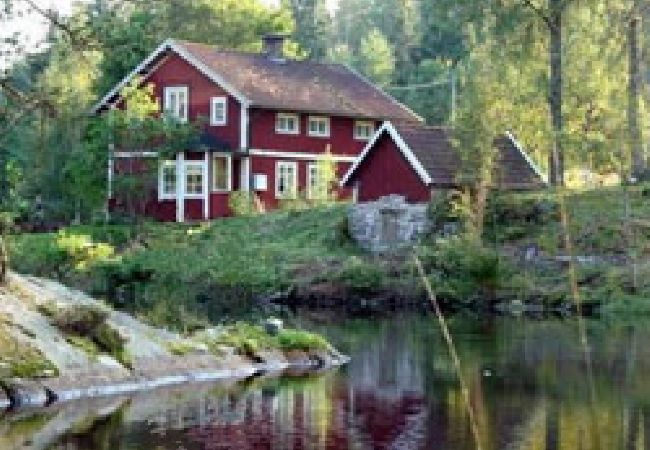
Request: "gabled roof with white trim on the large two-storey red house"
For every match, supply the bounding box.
[94,40,421,121]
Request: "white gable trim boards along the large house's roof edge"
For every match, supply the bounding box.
[91,39,251,114]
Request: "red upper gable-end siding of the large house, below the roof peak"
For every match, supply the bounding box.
[147,55,241,149]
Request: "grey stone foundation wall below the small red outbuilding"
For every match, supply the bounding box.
[348,195,431,253]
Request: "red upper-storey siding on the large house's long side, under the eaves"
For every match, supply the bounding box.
[250,109,367,156]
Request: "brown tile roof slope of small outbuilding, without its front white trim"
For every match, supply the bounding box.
[356,123,544,189]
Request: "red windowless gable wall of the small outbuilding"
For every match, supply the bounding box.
[350,134,431,202]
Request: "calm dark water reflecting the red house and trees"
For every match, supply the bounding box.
[0,317,650,450]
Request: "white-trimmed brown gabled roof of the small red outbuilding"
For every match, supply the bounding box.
[341,122,545,189]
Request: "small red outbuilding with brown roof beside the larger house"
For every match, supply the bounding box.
[341,122,545,203]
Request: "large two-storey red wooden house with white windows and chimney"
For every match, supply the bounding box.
[94,35,421,222]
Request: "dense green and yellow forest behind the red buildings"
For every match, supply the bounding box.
[0,0,650,221]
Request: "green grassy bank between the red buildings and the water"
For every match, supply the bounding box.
[11,188,650,331]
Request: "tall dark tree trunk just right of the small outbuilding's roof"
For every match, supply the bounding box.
[548,0,564,186]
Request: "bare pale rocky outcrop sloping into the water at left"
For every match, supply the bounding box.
[0,274,347,408]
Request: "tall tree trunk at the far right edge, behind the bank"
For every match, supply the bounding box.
[627,0,646,178]
